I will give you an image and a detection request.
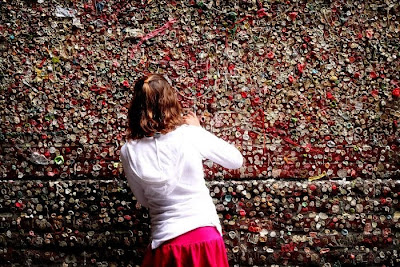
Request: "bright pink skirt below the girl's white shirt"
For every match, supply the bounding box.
[142,226,229,267]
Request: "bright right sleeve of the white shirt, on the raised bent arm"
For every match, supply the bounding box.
[189,125,243,169]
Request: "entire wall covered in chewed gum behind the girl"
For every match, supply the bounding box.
[0,0,400,266]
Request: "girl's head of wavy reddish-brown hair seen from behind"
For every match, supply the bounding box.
[128,74,183,139]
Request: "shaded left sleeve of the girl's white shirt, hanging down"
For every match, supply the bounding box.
[120,145,149,208]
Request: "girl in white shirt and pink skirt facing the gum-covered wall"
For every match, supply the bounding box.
[121,74,243,267]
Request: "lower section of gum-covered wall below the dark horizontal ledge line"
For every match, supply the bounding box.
[0,179,400,266]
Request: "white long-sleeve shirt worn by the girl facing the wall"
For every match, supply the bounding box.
[120,124,243,249]
